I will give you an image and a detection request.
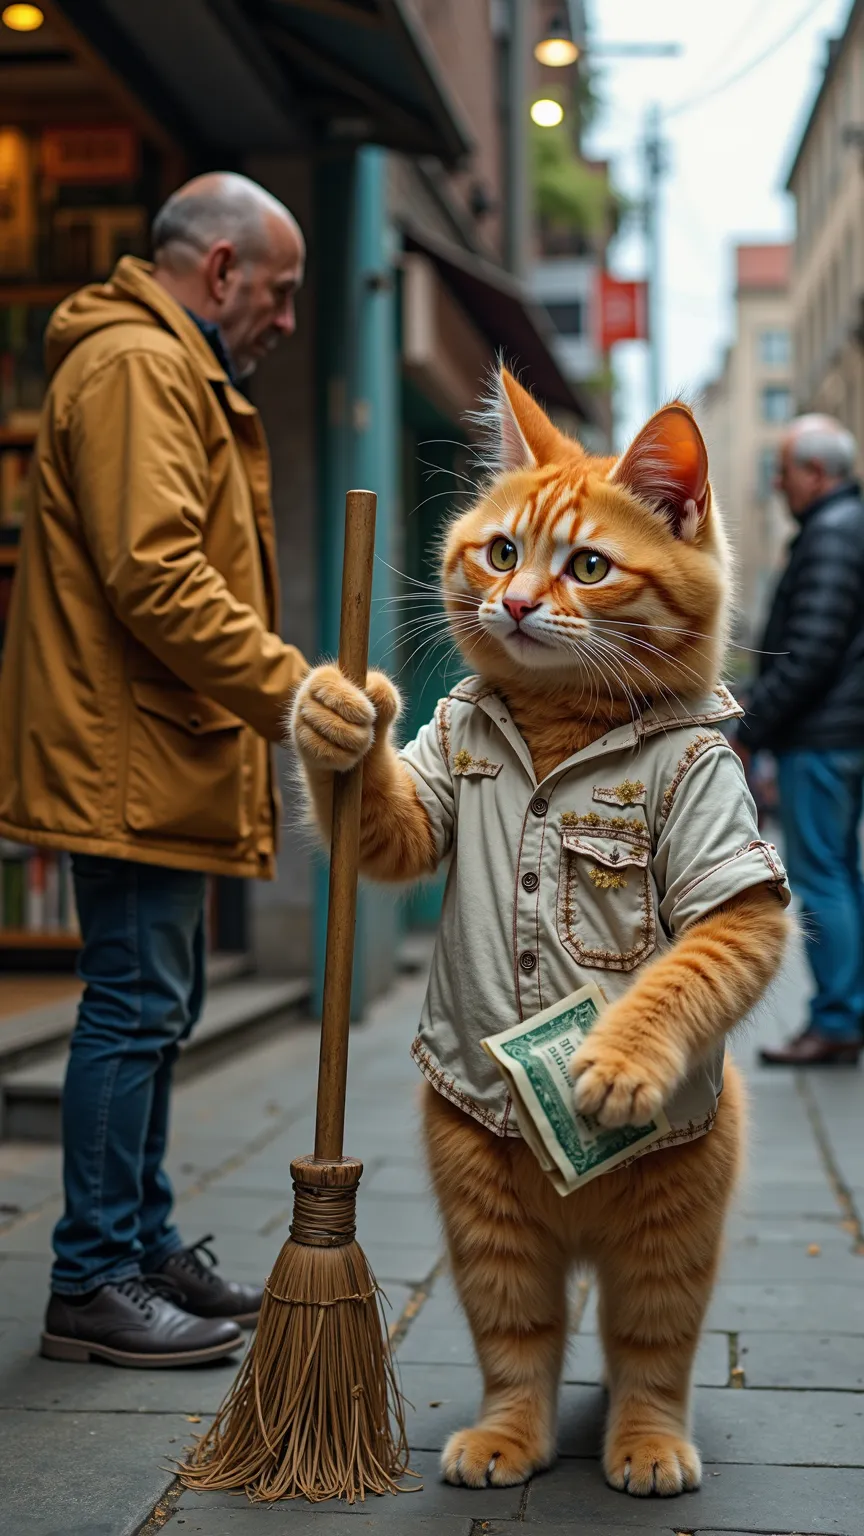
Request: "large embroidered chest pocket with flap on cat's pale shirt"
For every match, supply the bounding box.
[558,831,656,971]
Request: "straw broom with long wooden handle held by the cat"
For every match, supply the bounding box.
[180,490,407,1502]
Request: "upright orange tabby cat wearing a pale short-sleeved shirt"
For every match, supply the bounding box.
[292,372,789,1495]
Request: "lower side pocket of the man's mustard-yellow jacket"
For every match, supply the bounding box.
[126,682,249,843]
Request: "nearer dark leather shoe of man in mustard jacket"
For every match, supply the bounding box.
[42,1276,243,1369]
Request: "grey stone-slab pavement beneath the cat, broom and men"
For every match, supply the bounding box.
[0,921,864,1536]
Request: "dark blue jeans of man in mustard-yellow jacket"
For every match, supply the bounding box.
[51,854,204,1295]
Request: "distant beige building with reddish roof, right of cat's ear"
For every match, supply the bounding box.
[700,244,793,654]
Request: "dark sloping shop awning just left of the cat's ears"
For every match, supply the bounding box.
[404,226,596,422]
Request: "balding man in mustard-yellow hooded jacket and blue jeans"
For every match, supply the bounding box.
[0,174,306,1366]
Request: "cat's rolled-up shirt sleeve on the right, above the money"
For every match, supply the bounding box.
[653,743,790,935]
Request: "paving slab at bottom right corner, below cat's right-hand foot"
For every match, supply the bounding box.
[522,1461,864,1536]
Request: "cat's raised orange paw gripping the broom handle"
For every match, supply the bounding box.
[291,665,379,773]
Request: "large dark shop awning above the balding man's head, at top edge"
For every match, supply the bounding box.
[57,0,470,164]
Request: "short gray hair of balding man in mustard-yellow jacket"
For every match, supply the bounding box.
[152,170,294,266]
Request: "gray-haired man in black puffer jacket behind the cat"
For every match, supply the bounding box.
[739,416,864,1066]
